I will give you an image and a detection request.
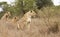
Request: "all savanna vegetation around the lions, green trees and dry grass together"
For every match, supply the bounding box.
[0,0,60,37]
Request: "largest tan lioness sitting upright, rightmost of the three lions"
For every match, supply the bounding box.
[17,10,36,30]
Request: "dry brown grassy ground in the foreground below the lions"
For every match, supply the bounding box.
[0,18,60,37]
